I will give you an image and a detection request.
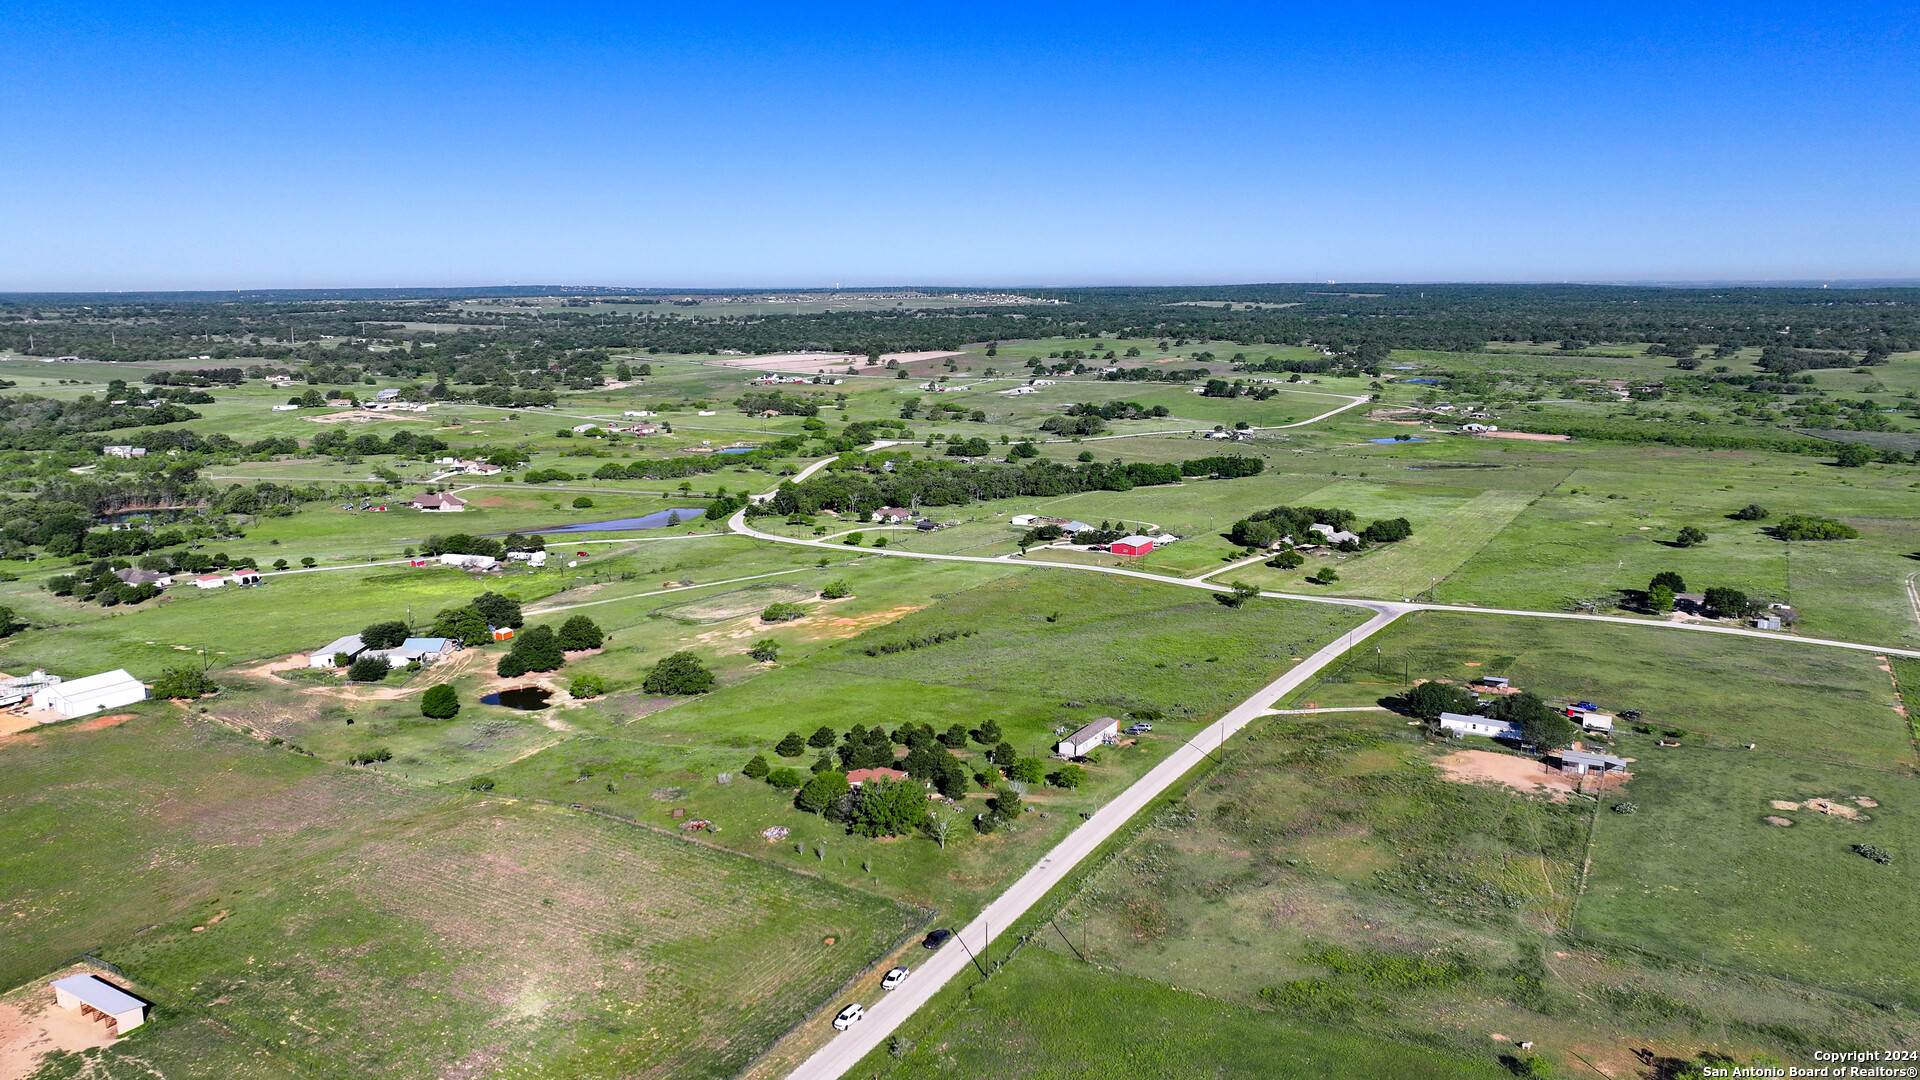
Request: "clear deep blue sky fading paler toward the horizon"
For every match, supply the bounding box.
[0,0,1920,290]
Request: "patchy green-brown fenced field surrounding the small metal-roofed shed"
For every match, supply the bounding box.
[0,705,924,1078]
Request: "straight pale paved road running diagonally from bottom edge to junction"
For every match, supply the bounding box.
[791,605,1405,1080]
